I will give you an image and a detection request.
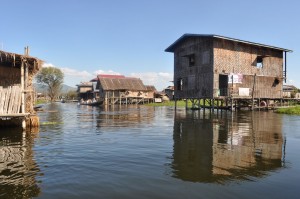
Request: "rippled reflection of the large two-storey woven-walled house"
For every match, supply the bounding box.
[172,111,284,183]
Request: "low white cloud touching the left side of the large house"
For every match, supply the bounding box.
[130,72,173,90]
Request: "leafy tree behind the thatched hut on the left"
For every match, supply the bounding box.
[35,67,64,101]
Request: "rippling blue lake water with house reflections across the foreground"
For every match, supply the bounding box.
[0,103,300,199]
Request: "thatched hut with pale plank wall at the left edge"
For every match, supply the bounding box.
[0,47,43,129]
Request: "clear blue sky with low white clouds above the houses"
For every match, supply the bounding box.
[0,0,300,90]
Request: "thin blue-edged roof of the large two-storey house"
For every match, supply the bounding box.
[165,34,293,52]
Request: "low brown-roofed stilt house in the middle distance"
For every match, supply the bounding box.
[97,75,155,105]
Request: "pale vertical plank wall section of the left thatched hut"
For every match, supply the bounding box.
[0,85,22,115]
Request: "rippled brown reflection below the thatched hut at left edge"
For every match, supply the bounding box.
[0,127,40,198]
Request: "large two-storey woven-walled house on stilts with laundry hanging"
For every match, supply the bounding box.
[165,34,292,109]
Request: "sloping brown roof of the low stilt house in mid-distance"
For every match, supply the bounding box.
[98,75,147,91]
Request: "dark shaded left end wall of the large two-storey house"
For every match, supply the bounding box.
[174,38,214,99]
